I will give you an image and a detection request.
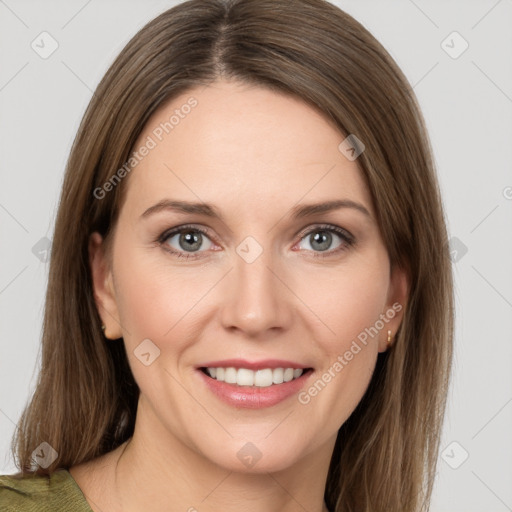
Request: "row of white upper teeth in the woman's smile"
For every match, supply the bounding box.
[206,367,304,388]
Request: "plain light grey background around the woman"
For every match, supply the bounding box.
[0,0,512,512]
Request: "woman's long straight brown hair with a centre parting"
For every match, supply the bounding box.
[13,0,453,512]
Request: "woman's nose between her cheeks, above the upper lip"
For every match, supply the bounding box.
[221,245,293,339]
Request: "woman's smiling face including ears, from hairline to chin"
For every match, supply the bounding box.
[91,81,406,472]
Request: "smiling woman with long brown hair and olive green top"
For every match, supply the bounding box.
[0,0,453,512]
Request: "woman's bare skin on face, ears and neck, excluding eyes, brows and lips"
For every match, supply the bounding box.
[70,81,407,512]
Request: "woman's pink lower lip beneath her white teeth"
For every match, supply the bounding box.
[197,370,312,409]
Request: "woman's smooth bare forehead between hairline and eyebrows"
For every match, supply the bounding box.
[122,82,372,219]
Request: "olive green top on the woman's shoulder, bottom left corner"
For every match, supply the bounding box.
[0,469,93,512]
